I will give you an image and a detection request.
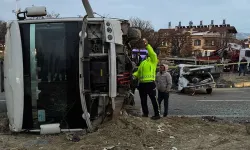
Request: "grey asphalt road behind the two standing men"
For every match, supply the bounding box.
[135,88,250,118]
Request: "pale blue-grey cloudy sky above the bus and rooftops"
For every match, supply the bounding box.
[0,0,250,33]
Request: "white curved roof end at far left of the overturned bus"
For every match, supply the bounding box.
[4,21,24,132]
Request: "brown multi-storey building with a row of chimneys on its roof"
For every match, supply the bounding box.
[158,20,237,56]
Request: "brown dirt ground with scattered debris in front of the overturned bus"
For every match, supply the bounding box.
[0,112,250,150]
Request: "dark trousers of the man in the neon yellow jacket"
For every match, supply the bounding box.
[138,82,160,116]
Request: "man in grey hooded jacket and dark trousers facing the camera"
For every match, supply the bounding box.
[156,65,172,117]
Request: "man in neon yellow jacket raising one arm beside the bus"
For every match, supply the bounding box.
[133,39,160,120]
